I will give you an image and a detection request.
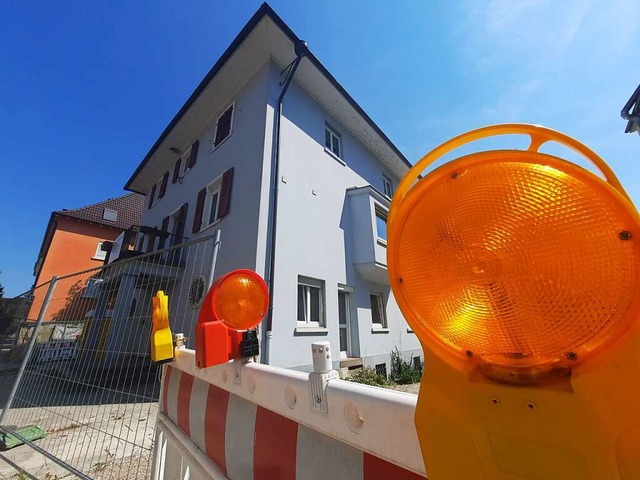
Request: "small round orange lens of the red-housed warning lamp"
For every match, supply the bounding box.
[211,270,269,330]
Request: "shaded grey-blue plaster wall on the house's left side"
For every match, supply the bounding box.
[141,63,269,338]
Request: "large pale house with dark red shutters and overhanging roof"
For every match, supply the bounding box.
[125,4,421,370]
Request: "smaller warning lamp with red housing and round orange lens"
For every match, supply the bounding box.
[195,269,269,368]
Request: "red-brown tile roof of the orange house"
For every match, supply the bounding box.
[54,193,145,230]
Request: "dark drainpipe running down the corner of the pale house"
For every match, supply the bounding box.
[262,40,309,364]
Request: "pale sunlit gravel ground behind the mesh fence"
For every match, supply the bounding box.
[0,371,158,480]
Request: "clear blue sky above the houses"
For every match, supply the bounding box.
[0,0,640,296]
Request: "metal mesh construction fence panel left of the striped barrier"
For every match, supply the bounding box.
[0,237,216,479]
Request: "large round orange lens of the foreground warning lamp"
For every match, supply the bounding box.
[388,151,640,369]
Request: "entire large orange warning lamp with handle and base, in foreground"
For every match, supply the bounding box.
[387,124,640,480]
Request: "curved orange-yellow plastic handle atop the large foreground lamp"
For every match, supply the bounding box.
[389,123,633,221]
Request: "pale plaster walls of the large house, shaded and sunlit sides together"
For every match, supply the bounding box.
[134,58,420,369]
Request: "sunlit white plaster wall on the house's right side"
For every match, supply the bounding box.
[263,64,420,369]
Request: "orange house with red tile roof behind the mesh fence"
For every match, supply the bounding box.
[29,193,144,320]
